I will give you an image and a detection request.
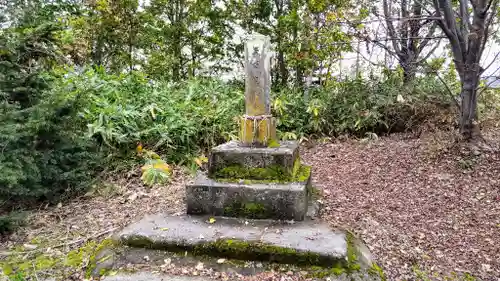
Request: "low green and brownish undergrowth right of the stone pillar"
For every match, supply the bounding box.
[274,74,454,136]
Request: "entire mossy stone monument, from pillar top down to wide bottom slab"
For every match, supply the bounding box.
[111,34,376,280]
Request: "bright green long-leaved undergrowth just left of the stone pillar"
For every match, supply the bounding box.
[52,69,243,162]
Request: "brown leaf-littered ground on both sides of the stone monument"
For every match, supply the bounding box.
[0,130,500,280]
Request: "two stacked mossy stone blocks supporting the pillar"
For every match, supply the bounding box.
[186,139,311,221]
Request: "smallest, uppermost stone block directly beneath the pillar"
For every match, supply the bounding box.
[209,141,299,175]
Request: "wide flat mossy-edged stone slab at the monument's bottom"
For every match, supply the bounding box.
[115,214,372,268]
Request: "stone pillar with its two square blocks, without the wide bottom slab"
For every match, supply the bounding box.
[186,33,311,221]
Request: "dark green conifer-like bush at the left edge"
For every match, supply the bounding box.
[0,24,103,201]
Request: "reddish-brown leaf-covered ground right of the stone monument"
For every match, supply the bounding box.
[304,130,500,280]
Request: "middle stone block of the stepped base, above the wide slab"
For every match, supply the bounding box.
[186,172,311,221]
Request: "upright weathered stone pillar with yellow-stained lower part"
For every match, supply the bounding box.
[240,35,276,147]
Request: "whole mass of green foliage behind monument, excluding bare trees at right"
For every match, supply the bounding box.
[0,0,497,206]
